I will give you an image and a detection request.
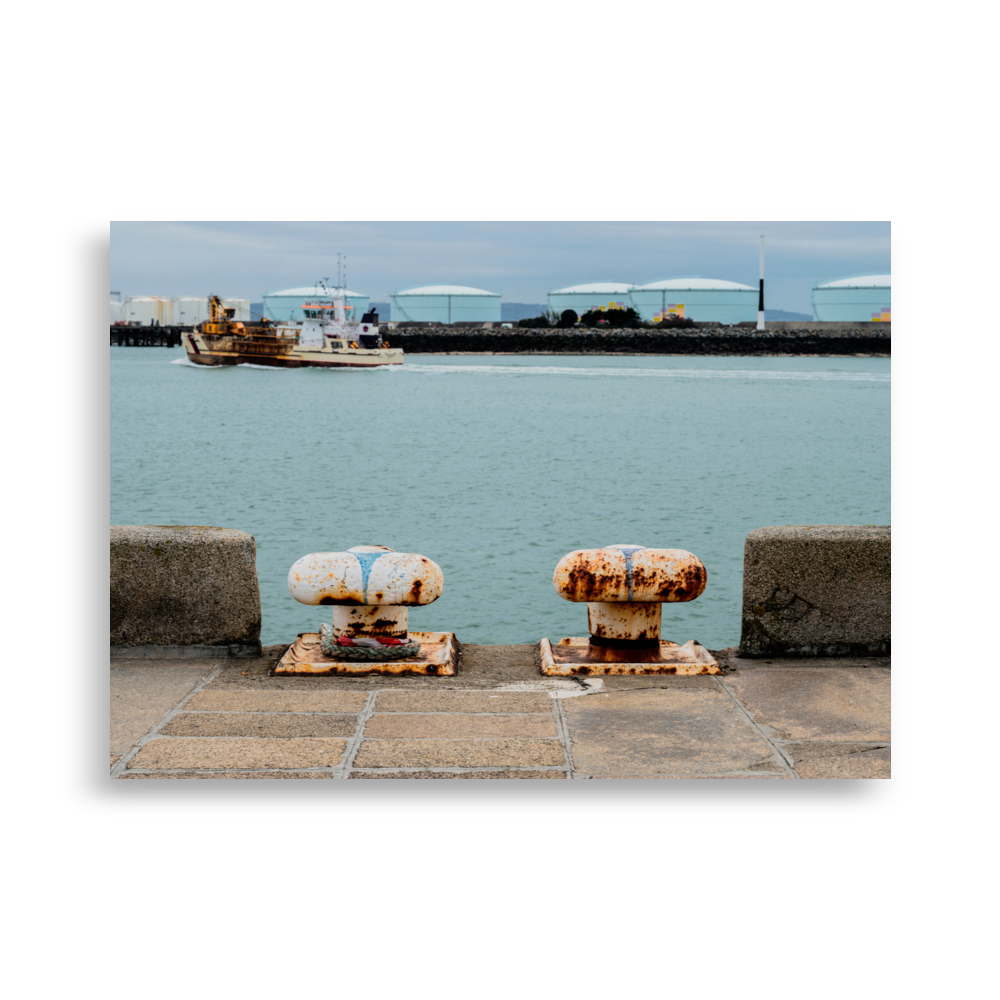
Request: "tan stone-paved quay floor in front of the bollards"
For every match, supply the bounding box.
[110,644,892,780]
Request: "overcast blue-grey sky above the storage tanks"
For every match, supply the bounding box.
[111,222,892,312]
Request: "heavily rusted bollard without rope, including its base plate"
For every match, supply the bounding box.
[539,545,721,674]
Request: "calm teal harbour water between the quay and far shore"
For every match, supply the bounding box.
[111,347,892,649]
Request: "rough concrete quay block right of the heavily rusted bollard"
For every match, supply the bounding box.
[739,524,892,657]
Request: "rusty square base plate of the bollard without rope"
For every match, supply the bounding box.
[538,639,722,677]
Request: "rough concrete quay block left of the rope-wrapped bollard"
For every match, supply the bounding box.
[110,525,261,659]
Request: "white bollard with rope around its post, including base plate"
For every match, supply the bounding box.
[275,545,458,675]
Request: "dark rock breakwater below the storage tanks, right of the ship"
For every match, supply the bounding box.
[387,324,892,355]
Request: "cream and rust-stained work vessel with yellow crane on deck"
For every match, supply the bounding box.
[182,295,403,368]
